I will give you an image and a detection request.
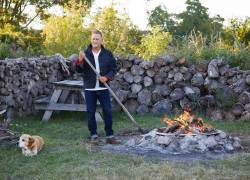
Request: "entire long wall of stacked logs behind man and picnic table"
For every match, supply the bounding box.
[0,55,250,119]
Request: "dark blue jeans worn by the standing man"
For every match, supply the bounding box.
[85,89,113,136]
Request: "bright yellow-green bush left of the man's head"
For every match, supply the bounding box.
[43,2,90,57]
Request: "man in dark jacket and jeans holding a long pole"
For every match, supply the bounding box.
[76,30,119,144]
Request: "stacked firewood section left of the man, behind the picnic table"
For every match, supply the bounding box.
[0,54,68,116]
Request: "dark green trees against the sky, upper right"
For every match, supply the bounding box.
[149,0,224,37]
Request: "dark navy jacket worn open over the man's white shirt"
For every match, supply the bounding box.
[76,44,116,89]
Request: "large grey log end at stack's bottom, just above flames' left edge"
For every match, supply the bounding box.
[152,99,173,114]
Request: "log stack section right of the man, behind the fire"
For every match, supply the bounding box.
[111,55,250,119]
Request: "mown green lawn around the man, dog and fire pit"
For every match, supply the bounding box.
[0,113,250,180]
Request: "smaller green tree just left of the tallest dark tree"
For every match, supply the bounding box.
[149,6,176,32]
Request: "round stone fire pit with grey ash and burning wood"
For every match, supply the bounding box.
[99,111,242,159]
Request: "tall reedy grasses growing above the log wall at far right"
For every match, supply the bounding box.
[167,31,250,69]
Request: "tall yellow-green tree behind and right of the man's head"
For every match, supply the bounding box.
[90,6,140,55]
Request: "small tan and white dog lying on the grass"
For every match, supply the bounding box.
[19,134,44,156]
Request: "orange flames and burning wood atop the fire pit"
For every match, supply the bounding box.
[162,110,212,134]
